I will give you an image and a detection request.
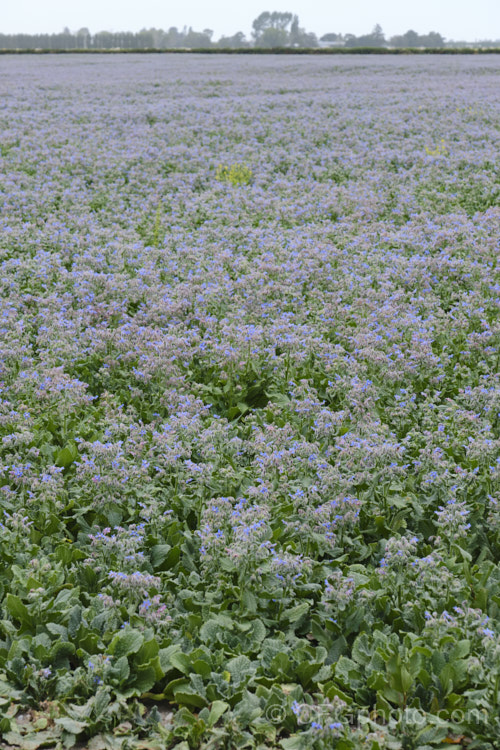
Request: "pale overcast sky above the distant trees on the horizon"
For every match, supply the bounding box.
[0,0,500,41]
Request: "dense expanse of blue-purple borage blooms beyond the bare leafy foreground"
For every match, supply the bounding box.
[0,55,500,664]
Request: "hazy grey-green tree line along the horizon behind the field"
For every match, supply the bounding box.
[0,11,498,50]
